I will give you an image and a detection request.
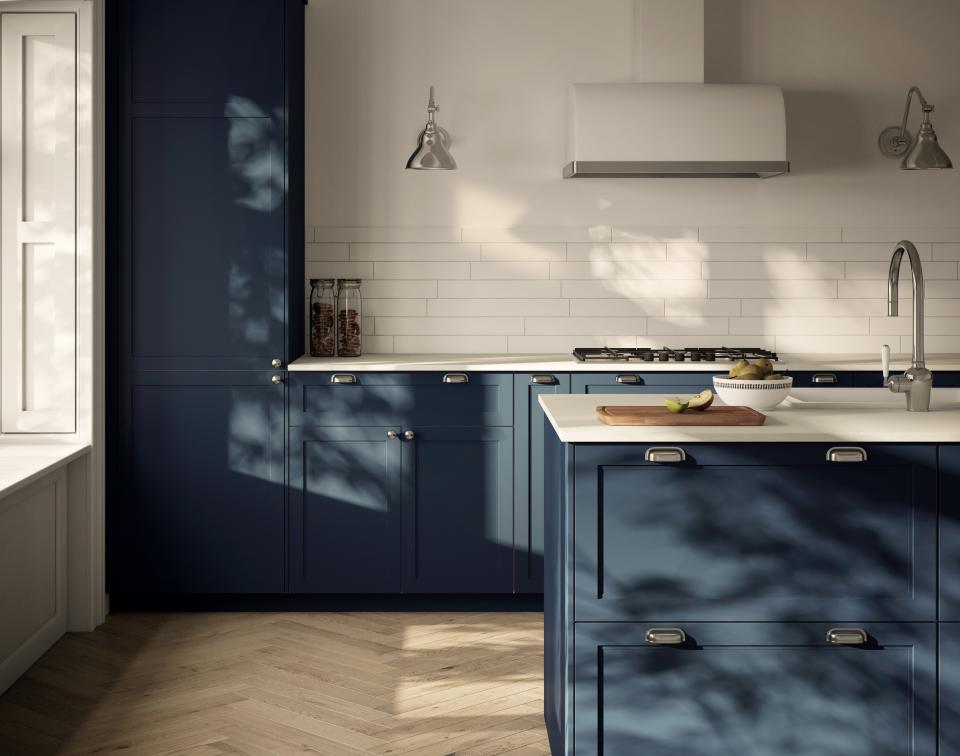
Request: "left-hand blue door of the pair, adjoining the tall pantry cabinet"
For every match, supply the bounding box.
[289,427,401,593]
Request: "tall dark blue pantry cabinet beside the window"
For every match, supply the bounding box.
[107,0,304,595]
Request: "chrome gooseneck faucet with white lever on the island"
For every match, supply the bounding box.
[880,241,933,412]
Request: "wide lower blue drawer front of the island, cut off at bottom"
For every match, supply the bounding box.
[573,618,932,756]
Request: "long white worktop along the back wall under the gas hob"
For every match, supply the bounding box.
[289,354,960,373]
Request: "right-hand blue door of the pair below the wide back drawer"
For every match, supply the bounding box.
[402,427,513,594]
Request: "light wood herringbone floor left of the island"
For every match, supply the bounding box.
[0,613,549,756]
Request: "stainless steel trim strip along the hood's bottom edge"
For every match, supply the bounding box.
[563,160,790,178]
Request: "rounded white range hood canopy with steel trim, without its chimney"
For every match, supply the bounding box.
[563,83,790,178]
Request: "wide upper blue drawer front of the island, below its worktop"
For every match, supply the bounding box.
[573,444,937,622]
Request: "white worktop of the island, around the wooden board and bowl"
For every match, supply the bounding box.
[540,394,960,444]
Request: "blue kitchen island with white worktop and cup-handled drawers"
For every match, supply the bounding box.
[540,395,960,756]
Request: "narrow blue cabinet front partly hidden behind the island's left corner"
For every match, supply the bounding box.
[513,373,570,593]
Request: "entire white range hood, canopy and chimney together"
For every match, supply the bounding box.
[563,0,790,178]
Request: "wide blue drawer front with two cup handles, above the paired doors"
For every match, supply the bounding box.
[290,372,513,430]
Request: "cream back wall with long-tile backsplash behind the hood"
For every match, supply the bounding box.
[306,0,960,353]
